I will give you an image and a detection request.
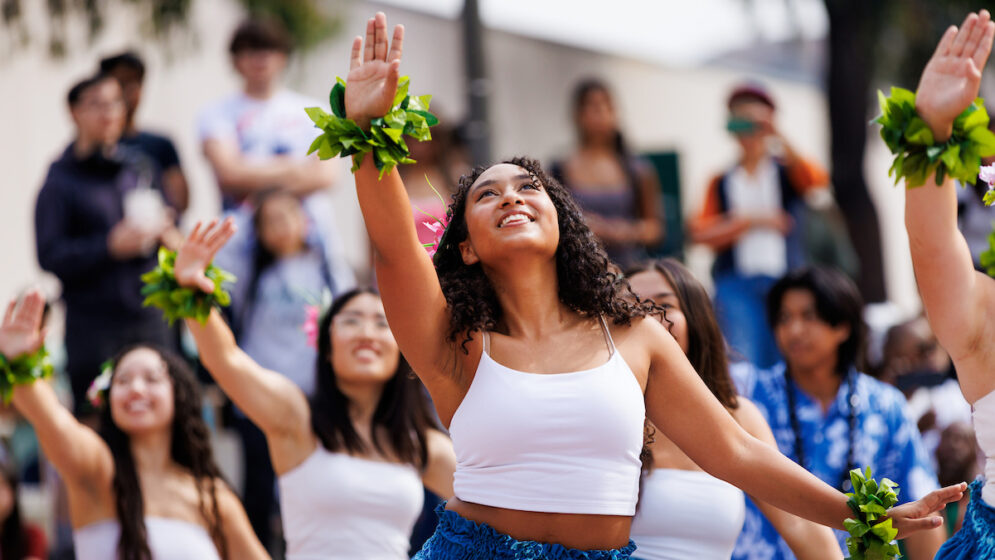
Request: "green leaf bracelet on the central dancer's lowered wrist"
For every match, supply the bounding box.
[843,467,900,560]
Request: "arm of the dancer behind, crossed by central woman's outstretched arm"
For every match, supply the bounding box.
[733,397,843,560]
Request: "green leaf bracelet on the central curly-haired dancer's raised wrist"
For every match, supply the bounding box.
[305,76,439,178]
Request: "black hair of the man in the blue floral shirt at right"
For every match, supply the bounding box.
[767,266,867,376]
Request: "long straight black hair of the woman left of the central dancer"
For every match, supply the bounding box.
[310,288,436,469]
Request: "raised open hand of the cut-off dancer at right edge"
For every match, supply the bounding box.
[916,10,995,141]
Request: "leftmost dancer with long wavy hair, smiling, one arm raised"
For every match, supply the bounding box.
[0,291,268,560]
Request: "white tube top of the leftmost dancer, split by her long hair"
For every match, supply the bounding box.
[73,517,221,560]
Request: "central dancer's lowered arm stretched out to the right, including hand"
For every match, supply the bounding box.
[634,319,966,538]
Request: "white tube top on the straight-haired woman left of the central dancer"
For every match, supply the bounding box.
[279,444,425,560]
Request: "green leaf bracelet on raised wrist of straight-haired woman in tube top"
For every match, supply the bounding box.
[142,247,235,325]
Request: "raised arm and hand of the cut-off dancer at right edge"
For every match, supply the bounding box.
[905,10,995,402]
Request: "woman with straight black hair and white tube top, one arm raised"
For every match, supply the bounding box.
[175,221,456,560]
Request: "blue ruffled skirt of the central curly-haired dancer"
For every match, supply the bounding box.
[414,502,636,560]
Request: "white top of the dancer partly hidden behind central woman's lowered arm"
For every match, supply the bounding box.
[631,469,746,560]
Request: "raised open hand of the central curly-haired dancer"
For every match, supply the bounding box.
[345,12,404,129]
